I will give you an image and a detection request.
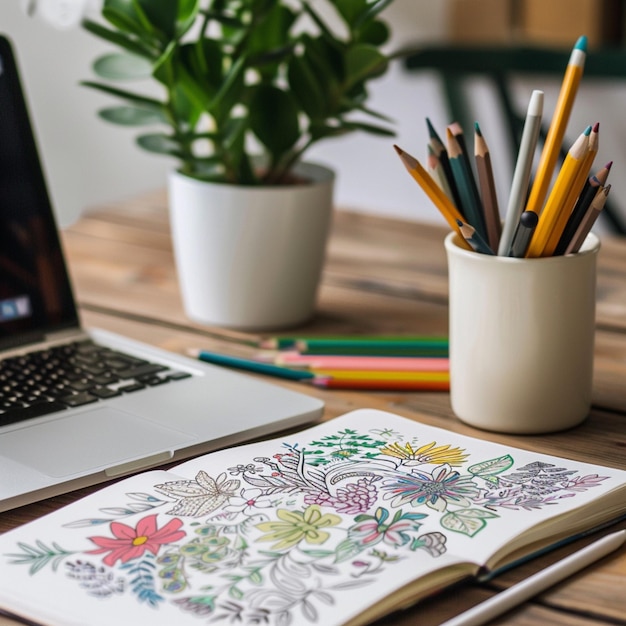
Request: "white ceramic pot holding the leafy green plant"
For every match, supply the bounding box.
[169,163,334,330]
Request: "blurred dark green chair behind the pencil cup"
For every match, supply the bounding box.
[403,46,626,235]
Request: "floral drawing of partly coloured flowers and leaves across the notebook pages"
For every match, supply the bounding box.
[5,428,606,626]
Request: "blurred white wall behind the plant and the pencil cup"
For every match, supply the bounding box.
[0,0,626,230]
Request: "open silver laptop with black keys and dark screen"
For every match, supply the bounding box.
[0,36,323,511]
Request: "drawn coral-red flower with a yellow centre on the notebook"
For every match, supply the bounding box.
[87,515,186,567]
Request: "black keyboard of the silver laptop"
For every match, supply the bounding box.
[0,340,191,426]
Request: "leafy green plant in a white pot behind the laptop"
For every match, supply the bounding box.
[83,0,393,328]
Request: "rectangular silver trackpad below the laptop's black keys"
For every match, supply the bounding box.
[1,407,192,477]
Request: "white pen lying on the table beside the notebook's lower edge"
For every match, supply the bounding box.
[441,530,626,626]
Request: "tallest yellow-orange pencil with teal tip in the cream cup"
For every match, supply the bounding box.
[526,36,587,217]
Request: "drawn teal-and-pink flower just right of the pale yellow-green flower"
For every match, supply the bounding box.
[348,507,426,547]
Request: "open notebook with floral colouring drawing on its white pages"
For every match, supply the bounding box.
[0,409,626,626]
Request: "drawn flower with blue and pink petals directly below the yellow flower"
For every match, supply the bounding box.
[383,463,480,512]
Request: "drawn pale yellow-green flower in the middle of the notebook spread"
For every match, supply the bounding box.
[256,504,341,550]
